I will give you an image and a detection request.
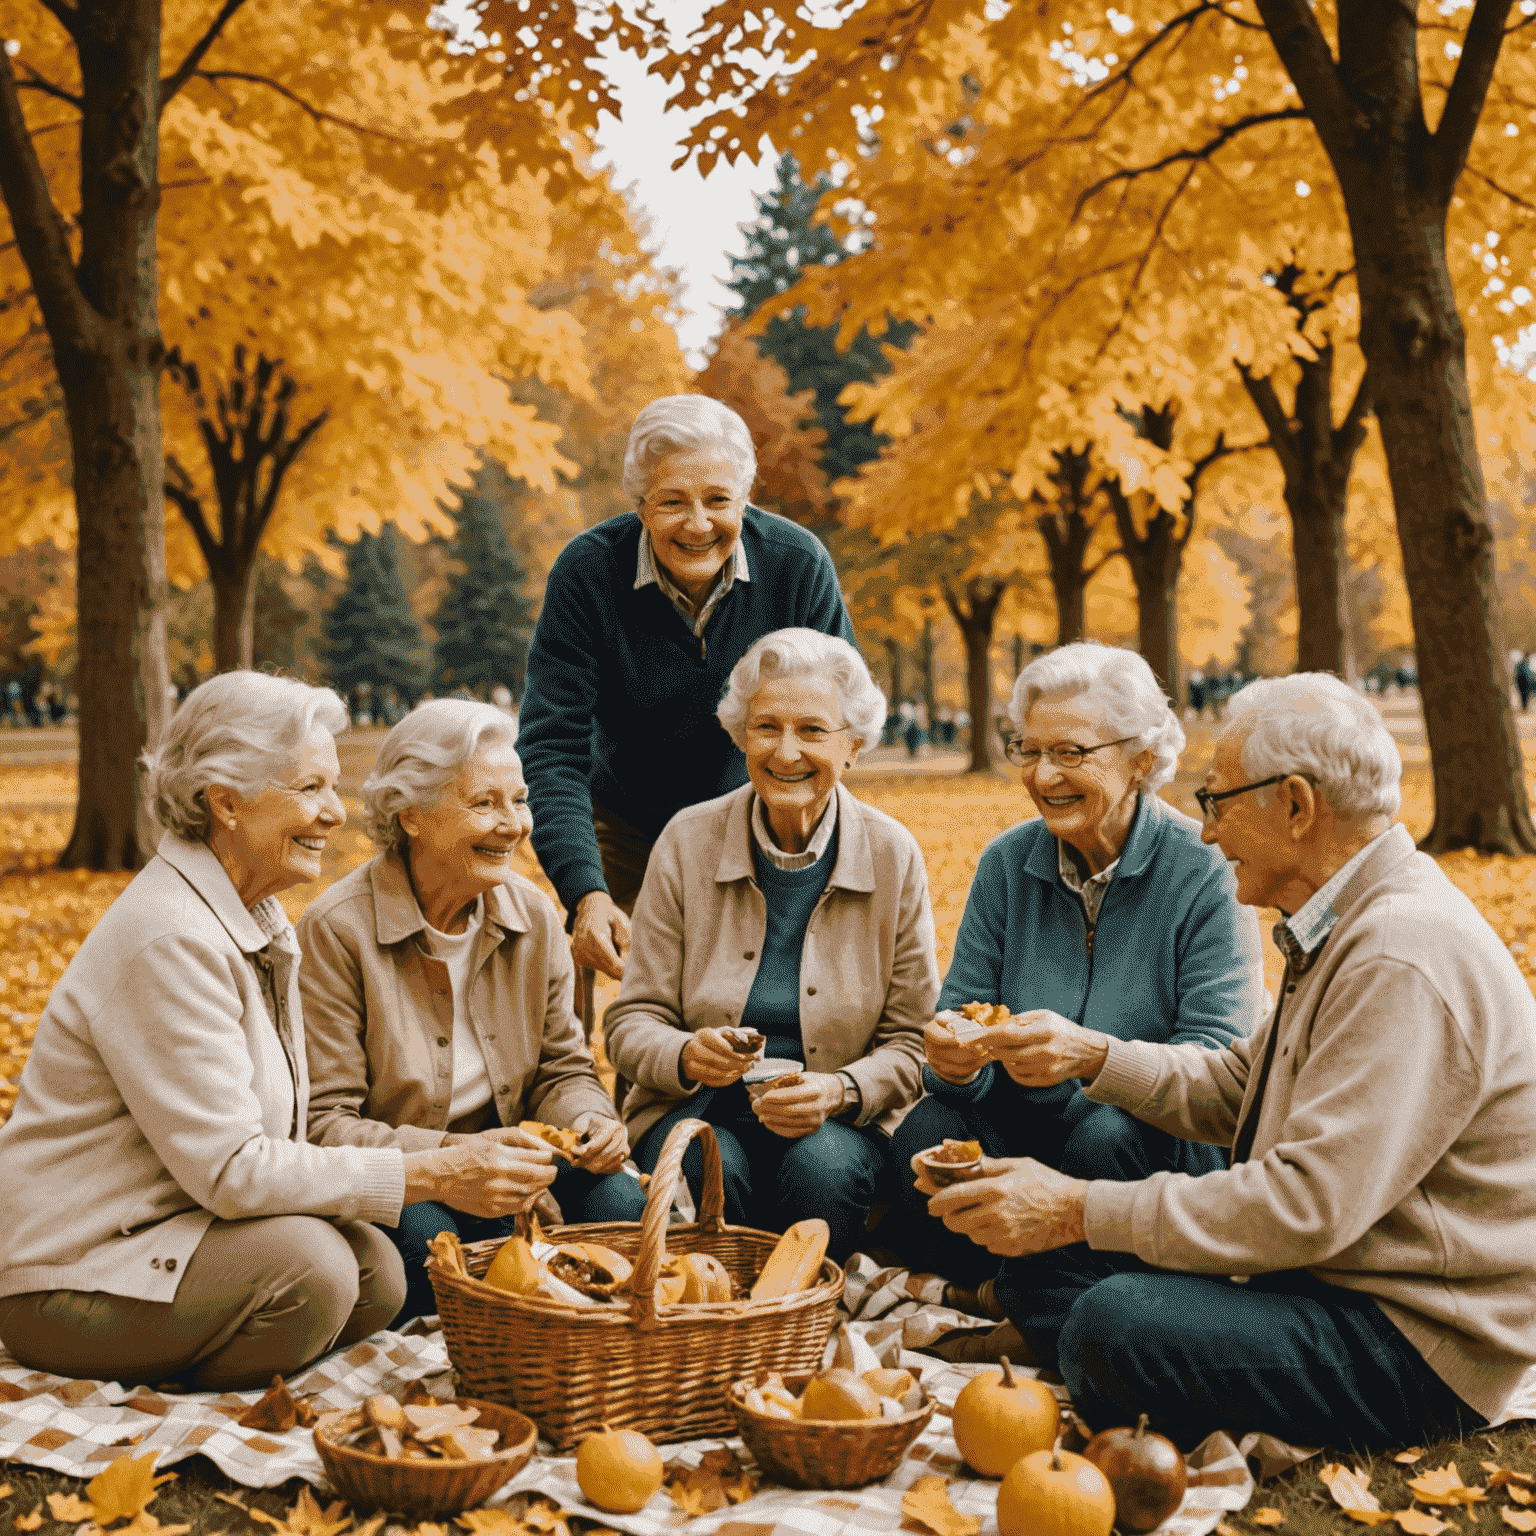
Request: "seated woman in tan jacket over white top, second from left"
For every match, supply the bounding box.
[300,699,645,1316]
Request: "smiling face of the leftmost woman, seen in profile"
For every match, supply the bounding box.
[219,725,347,906]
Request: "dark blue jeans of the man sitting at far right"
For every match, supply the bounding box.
[1019,1246,1487,1452]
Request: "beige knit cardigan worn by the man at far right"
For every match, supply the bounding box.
[1087,826,1536,1422]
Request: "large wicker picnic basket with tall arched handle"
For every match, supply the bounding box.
[427,1120,843,1448]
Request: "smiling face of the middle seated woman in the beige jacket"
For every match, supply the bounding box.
[746,677,857,852]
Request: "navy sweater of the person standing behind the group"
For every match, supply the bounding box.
[518,507,854,911]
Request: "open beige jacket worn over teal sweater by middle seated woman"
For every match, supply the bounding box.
[604,785,938,1143]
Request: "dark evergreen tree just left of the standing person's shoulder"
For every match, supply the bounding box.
[432,459,533,699]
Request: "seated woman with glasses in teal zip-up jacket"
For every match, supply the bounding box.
[894,642,1264,1322]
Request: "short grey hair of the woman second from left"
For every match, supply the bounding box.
[362,699,518,852]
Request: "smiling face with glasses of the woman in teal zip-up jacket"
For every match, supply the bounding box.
[1020,693,1152,868]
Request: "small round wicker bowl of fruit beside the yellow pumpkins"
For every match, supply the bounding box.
[727,1372,934,1488]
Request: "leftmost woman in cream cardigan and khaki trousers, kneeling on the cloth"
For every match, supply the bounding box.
[0,671,553,1392]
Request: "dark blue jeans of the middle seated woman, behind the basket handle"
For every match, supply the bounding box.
[634,1083,888,1263]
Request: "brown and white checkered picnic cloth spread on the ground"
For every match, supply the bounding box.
[0,1255,1253,1536]
